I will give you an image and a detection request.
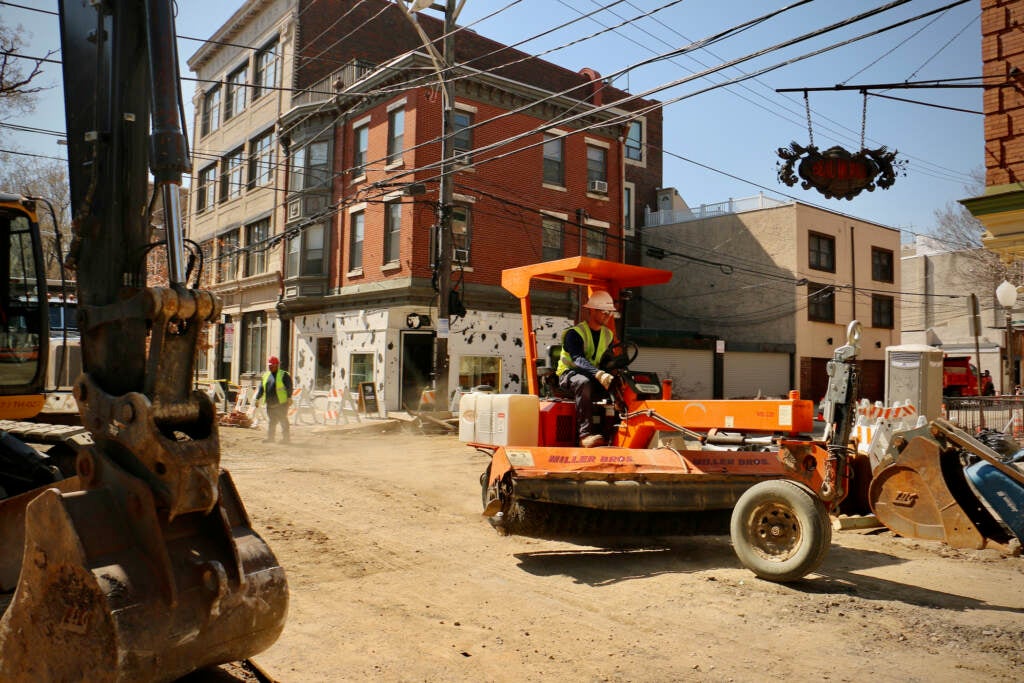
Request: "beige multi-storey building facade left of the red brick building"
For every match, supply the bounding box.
[188,0,297,384]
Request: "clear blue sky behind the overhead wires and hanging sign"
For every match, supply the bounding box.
[6,0,984,239]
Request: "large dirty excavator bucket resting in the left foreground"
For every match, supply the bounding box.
[0,451,288,681]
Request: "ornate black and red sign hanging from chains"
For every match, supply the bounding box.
[777,142,906,200]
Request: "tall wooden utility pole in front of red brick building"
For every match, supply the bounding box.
[433,0,456,411]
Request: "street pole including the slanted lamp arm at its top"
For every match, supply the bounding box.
[397,0,466,411]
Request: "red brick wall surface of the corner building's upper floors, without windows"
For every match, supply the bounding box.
[332,88,622,287]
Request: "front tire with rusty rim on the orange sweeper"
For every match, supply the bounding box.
[729,479,831,583]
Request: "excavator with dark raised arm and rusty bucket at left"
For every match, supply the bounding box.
[0,0,288,681]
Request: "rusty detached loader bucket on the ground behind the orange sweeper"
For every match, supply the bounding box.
[868,423,995,549]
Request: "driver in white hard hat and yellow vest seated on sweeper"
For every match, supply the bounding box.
[555,290,618,449]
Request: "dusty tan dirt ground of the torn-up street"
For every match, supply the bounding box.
[209,417,1024,683]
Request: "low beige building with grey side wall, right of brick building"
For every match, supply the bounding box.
[634,188,900,400]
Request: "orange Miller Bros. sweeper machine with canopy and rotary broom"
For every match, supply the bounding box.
[471,257,860,582]
